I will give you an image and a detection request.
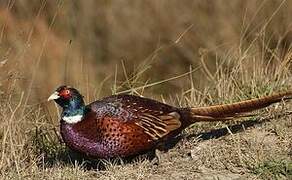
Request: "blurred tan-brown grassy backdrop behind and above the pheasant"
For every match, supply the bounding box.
[0,0,292,98]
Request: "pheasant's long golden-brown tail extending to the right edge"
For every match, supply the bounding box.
[190,90,292,122]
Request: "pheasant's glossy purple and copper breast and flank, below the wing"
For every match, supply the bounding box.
[61,114,155,158]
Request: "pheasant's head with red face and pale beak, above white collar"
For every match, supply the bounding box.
[48,86,84,108]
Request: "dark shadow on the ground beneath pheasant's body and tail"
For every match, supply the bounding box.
[38,114,286,170]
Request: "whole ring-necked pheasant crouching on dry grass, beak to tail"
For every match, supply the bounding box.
[48,86,292,159]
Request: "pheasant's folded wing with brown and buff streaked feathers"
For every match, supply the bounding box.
[91,95,181,140]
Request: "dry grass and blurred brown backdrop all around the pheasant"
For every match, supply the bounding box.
[0,0,292,179]
